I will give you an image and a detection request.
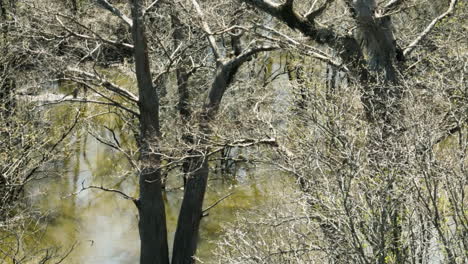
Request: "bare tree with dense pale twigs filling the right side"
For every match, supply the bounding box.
[216,1,467,263]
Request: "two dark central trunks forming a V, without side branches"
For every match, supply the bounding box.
[130,0,276,264]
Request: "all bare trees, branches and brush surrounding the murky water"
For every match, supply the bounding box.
[0,0,468,264]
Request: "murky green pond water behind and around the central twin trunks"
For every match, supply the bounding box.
[22,70,294,264]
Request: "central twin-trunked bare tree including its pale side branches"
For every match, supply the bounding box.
[31,1,278,263]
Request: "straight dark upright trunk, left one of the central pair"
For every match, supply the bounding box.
[132,0,169,264]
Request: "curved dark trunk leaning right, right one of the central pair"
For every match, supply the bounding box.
[172,8,276,258]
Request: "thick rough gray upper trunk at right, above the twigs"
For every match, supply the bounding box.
[351,0,402,126]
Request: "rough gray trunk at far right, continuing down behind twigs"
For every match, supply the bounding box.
[347,0,404,264]
